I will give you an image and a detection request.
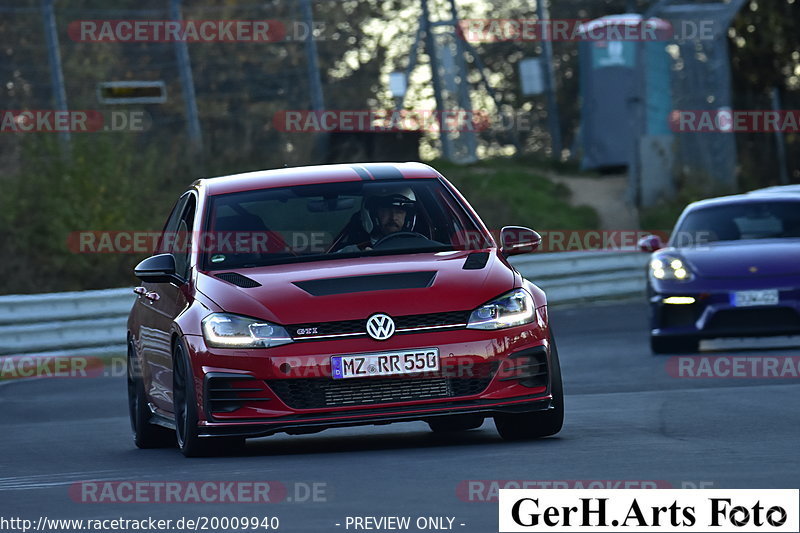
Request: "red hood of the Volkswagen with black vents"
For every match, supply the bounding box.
[197,251,516,324]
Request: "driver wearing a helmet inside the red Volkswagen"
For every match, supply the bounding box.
[339,187,417,252]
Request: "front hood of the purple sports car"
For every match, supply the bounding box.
[677,239,800,278]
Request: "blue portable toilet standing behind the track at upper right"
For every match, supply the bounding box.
[579,14,672,169]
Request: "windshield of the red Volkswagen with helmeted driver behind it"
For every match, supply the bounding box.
[196,179,491,270]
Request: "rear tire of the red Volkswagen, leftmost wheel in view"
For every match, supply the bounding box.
[127,342,175,449]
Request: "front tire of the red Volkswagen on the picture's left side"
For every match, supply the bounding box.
[172,341,244,457]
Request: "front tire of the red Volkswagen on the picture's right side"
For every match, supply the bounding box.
[494,333,564,441]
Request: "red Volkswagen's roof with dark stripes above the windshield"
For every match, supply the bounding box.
[194,163,442,196]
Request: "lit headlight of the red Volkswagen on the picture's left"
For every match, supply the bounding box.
[203,313,292,348]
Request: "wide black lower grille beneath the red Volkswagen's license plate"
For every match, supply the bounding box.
[267,370,494,409]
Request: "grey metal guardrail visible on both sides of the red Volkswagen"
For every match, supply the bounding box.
[0,252,649,356]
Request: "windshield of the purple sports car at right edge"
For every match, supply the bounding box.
[671,200,800,246]
